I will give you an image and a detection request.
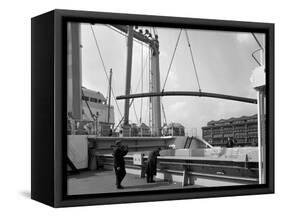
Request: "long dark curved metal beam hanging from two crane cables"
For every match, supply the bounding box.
[116,91,257,104]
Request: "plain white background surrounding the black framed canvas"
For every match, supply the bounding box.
[0,0,281,217]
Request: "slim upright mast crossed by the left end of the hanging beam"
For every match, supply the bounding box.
[124,26,133,125]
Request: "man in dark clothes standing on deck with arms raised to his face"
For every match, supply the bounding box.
[113,140,128,189]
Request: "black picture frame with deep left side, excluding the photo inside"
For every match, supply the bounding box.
[31,10,274,207]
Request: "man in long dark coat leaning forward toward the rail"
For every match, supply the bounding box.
[146,148,161,183]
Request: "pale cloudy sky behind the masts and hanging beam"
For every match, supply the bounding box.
[77,23,264,137]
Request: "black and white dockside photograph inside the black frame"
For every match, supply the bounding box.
[65,22,267,195]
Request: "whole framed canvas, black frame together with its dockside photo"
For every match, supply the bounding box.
[31,10,274,207]
